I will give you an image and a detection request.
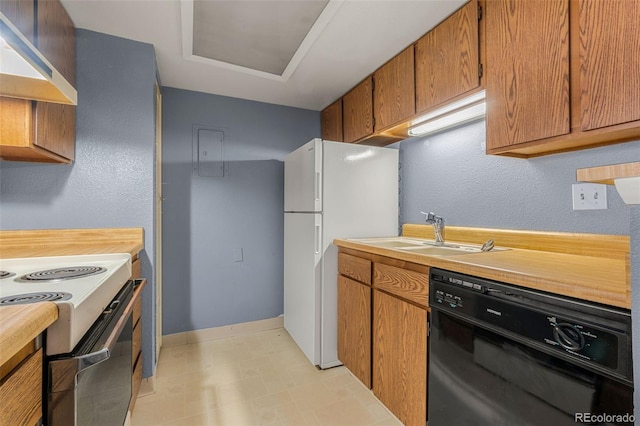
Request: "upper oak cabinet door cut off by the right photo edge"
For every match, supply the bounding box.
[579,0,640,130]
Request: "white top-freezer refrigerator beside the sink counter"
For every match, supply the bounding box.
[284,139,398,368]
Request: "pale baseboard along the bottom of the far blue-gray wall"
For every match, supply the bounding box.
[162,316,284,348]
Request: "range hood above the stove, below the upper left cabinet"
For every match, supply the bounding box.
[0,12,78,105]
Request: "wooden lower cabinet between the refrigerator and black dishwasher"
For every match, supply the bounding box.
[338,249,429,426]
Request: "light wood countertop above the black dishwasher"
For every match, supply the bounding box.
[334,225,631,309]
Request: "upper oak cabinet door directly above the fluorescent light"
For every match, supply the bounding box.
[415,0,480,113]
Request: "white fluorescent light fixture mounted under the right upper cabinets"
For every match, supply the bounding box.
[409,90,487,136]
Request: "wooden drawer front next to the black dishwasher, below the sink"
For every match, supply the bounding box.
[373,263,429,307]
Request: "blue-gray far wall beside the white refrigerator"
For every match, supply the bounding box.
[162,88,320,334]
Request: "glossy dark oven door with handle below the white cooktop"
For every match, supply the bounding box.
[47,281,134,426]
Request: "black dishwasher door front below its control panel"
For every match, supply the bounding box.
[428,307,633,426]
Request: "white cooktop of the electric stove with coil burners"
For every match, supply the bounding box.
[0,253,131,355]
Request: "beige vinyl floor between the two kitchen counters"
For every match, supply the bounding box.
[131,328,401,426]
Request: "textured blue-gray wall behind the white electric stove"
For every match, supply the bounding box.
[0,29,156,377]
